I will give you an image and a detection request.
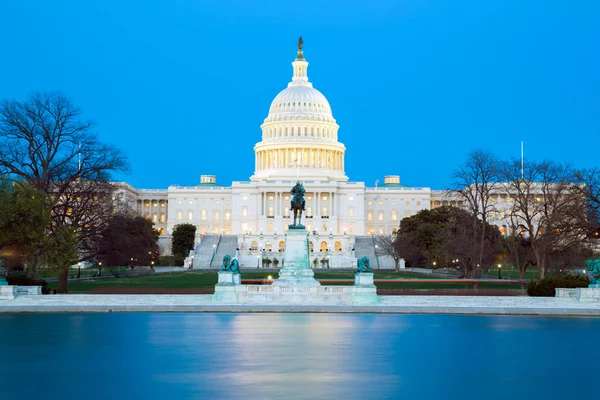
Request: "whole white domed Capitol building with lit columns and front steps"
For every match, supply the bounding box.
[119,40,472,268]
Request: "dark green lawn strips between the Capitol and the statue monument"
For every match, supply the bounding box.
[49,271,520,293]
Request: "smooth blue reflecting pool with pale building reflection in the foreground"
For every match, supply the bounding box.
[0,313,600,400]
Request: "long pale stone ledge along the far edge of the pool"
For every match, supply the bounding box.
[0,295,600,317]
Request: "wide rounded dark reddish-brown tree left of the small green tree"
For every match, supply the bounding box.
[97,215,159,267]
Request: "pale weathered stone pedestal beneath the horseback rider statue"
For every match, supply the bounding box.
[273,228,321,286]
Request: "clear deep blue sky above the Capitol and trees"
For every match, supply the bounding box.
[0,0,600,189]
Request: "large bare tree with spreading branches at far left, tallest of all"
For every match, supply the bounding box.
[0,93,127,290]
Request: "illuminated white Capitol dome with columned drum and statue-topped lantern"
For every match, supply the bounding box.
[250,39,348,181]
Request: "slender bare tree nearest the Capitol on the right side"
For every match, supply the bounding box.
[451,150,499,278]
